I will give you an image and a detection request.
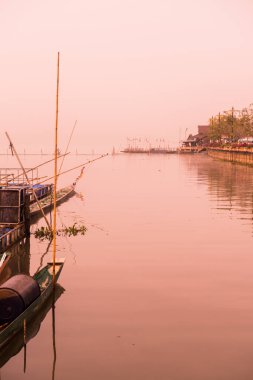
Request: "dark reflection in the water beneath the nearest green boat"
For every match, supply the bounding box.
[0,284,64,368]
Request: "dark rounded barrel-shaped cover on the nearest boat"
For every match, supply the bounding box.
[0,274,40,324]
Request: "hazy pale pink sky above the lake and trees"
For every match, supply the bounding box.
[0,0,253,152]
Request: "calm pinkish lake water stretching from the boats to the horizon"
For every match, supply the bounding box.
[0,154,253,380]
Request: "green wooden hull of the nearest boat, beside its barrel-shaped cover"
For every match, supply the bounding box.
[0,259,65,350]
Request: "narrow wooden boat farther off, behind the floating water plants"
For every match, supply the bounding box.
[30,185,75,222]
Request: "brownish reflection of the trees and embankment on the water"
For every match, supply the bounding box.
[180,155,253,221]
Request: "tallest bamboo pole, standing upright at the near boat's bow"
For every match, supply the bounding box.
[53,52,60,280]
